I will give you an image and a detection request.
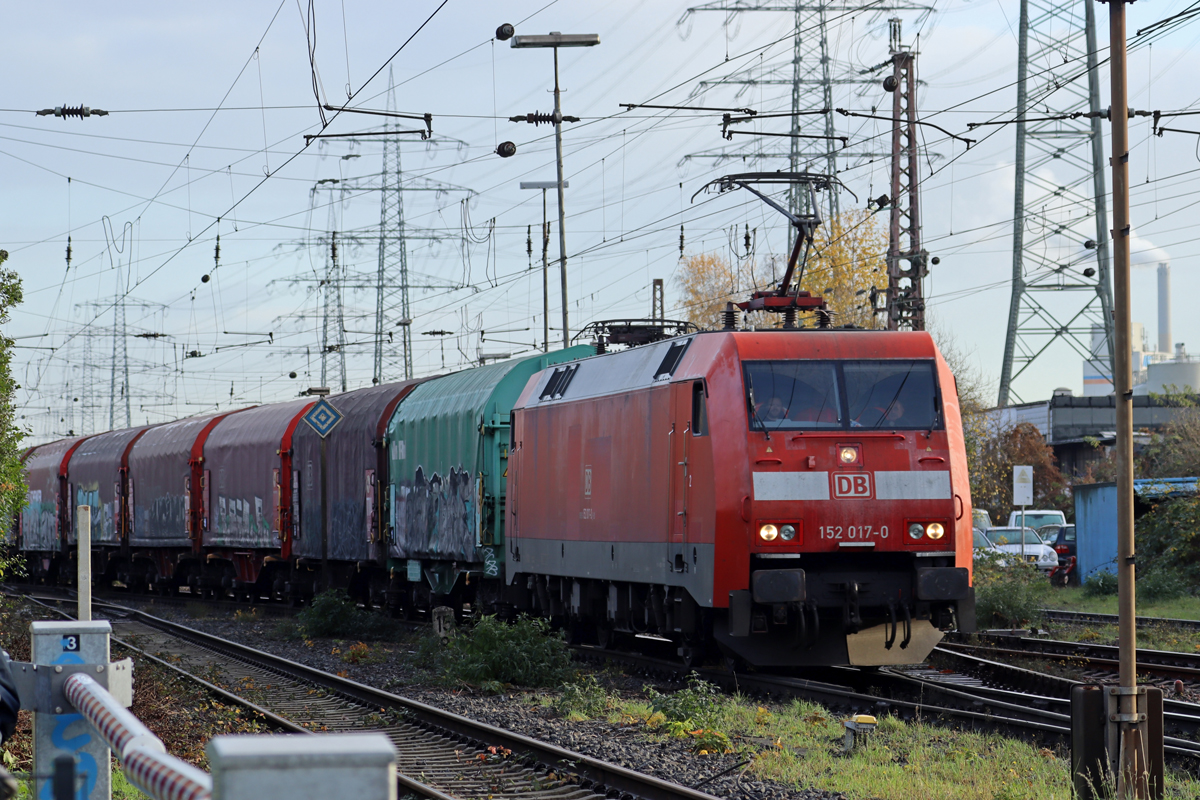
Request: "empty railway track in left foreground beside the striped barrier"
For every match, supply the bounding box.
[18,594,713,800]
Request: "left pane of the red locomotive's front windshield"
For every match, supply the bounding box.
[745,361,844,431]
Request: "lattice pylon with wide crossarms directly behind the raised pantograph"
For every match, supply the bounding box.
[680,0,932,218]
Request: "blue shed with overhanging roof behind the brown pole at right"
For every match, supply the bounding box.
[1073,477,1196,581]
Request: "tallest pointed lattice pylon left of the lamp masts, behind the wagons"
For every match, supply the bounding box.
[372,70,413,384]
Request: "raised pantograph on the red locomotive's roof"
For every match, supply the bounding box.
[692,172,858,330]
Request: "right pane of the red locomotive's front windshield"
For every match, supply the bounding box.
[842,361,941,429]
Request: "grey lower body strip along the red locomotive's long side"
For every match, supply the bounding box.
[506,537,715,608]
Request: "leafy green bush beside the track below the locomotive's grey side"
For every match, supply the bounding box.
[419,616,571,692]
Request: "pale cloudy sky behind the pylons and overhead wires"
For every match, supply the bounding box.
[0,0,1200,440]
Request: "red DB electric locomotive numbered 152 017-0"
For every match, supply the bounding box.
[508,330,974,666]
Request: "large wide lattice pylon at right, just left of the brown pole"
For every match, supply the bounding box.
[997,0,1112,405]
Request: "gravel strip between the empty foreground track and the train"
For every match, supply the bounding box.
[110,602,846,800]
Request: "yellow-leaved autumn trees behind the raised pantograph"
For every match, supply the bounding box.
[676,210,888,327]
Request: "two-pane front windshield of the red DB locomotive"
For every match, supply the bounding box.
[743,361,942,431]
